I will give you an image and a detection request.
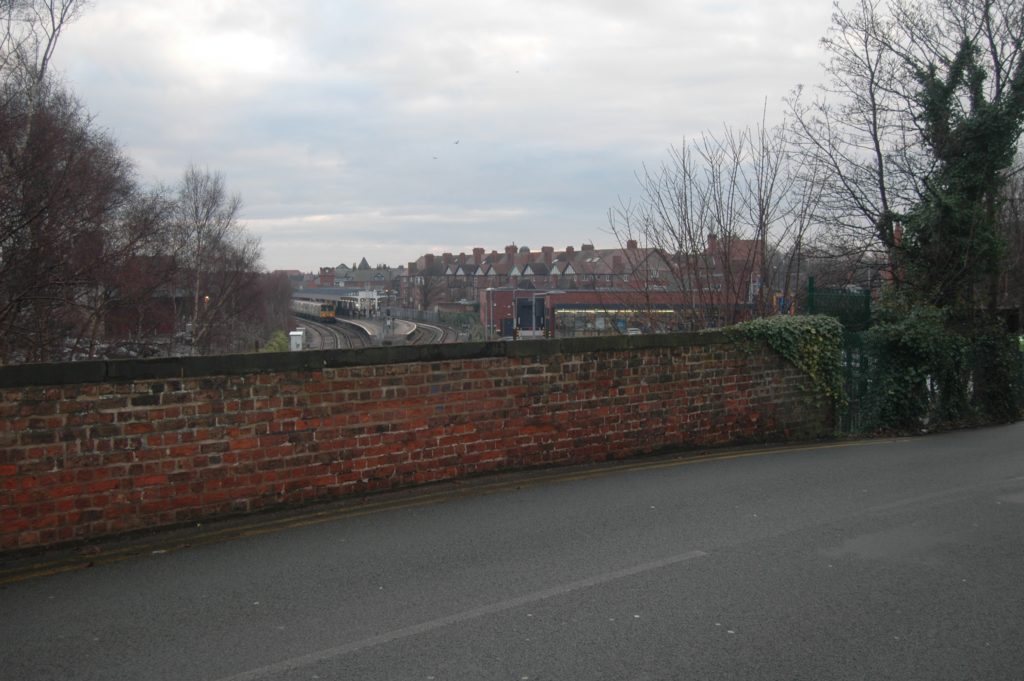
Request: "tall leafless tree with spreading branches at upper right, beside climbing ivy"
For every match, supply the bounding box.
[790,0,1024,301]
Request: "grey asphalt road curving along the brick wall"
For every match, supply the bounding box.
[0,425,1024,681]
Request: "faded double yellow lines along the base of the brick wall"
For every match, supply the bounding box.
[0,438,888,586]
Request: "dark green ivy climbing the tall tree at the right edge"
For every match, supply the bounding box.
[903,38,1024,309]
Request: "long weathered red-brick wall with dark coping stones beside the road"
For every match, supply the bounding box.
[0,334,831,550]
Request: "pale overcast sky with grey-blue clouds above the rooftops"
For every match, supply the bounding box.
[54,0,830,271]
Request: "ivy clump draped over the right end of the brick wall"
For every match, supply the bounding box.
[734,315,846,406]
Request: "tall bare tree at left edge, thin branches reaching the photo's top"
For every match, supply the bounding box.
[0,0,109,361]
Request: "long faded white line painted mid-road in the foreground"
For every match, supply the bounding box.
[209,551,708,681]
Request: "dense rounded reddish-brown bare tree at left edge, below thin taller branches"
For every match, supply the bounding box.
[0,78,142,360]
